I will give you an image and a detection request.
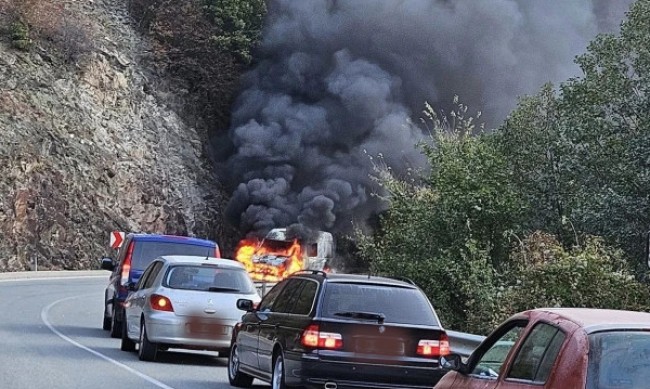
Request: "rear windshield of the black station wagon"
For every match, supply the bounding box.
[322,282,440,326]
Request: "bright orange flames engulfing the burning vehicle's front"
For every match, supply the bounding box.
[235,238,304,282]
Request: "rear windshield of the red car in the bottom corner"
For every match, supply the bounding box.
[587,331,650,389]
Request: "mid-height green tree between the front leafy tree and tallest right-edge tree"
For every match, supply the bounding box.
[493,84,580,247]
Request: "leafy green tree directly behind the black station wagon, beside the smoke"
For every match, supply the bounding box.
[358,104,523,332]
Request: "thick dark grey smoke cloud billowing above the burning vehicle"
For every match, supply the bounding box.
[228,0,631,233]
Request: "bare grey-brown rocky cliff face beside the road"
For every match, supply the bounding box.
[0,0,225,271]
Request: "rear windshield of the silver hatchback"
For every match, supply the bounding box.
[163,265,256,294]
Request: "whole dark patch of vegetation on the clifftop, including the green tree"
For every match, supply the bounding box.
[128,0,266,138]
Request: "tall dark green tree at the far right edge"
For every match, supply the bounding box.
[560,0,650,264]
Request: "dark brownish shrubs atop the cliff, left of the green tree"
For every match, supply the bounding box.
[129,0,249,138]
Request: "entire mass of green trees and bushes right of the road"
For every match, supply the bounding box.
[357,0,650,333]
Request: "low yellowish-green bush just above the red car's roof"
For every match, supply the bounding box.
[499,232,650,317]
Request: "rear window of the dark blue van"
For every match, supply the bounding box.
[131,241,215,270]
